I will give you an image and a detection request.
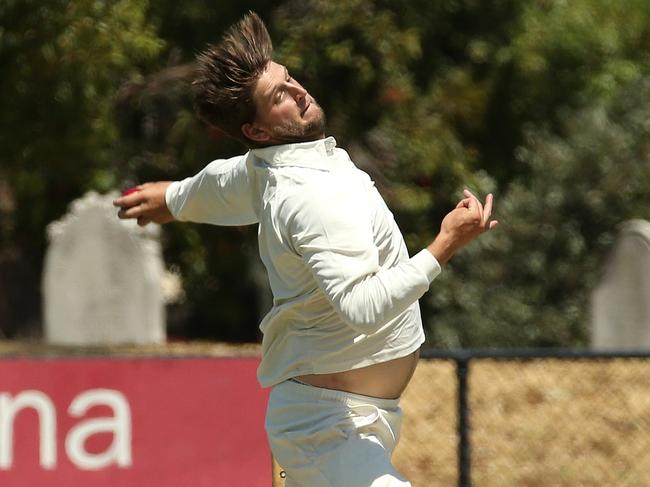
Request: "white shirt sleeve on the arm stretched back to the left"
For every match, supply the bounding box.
[165,155,258,225]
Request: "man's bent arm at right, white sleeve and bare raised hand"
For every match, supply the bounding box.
[292,188,497,334]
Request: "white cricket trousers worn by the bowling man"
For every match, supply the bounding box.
[266,380,411,487]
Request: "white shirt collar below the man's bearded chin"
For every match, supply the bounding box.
[252,137,336,170]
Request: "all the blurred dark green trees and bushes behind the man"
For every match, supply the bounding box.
[0,0,650,349]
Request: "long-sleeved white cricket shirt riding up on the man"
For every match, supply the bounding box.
[165,137,440,387]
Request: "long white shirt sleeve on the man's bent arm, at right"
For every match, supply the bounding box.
[289,175,441,334]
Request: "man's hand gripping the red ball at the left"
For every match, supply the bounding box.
[113,181,174,227]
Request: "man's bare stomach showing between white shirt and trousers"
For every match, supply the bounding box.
[295,349,420,399]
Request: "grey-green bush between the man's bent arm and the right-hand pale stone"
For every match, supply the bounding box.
[428,79,650,347]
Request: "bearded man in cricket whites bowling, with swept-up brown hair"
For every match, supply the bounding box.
[115,13,497,487]
